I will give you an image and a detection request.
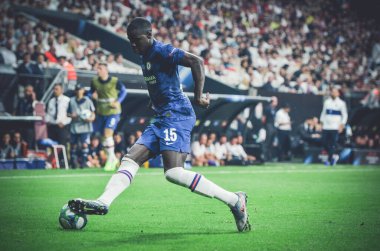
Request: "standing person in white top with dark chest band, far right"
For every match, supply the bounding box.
[320,87,347,165]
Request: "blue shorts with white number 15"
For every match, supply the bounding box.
[136,117,195,155]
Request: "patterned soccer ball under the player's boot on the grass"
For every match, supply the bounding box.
[58,204,87,230]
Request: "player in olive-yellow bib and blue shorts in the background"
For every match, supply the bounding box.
[91,62,127,171]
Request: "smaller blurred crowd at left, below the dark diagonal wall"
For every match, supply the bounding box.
[0,1,138,75]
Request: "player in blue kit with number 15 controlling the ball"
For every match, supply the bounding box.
[68,18,251,231]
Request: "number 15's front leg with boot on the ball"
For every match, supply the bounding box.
[68,144,153,215]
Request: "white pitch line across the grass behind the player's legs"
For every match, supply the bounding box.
[0,168,378,180]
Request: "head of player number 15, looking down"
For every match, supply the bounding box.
[127,17,153,55]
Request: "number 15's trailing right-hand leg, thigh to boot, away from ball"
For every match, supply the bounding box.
[161,151,251,232]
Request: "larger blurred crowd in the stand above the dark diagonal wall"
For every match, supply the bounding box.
[16,0,380,97]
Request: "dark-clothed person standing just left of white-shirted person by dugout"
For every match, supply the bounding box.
[263,97,278,161]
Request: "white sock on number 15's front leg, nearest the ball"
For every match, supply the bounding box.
[98,157,139,206]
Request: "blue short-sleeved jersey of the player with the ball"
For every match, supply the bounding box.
[141,40,195,121]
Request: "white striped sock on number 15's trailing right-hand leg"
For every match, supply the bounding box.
[165,167,238,206]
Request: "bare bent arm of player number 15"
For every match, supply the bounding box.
[179,52,210,108]
